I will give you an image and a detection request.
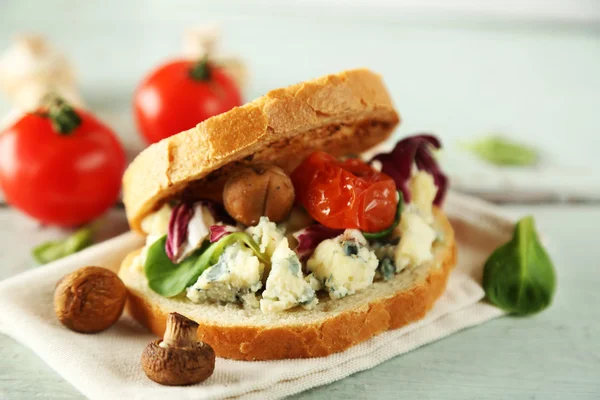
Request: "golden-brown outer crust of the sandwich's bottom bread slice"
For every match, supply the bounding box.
[121,210,456,360]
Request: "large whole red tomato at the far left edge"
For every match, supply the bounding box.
[0,102,125,227]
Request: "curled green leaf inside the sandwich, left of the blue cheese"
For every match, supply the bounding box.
[144,232,269,297]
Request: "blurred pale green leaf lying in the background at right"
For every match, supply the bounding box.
[463,136,538,167]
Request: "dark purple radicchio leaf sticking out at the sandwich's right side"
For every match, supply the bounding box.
[371,135,448,206]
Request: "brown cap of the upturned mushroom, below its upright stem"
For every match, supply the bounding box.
[141,339,215,386]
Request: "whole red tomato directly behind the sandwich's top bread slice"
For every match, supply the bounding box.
[134,60,242,143]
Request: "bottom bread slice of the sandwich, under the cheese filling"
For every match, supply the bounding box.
[119,209,456,360]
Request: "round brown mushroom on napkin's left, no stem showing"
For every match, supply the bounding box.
[54,267,127,333]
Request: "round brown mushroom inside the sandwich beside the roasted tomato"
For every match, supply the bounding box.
[223,164,295,226]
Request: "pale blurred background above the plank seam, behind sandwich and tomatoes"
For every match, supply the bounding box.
[0,0,600,206]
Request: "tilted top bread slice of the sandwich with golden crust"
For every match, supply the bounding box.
[123,69,399,231]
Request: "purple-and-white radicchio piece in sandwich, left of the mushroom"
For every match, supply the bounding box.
[165,200,231,263]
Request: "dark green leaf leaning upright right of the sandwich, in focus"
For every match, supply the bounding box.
[483,217,556,315]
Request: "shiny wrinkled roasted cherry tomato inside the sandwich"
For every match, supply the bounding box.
[292,152,398,232]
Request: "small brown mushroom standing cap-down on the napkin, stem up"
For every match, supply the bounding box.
[141,313,215,386]
